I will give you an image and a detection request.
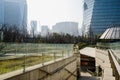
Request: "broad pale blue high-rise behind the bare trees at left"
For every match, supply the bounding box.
[4,0,27,28]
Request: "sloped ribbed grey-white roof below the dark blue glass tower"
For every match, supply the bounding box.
[100,27,120,39]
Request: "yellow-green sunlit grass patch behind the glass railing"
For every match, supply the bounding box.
[0,55,60,74]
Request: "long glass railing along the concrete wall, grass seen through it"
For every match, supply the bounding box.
[0,43,73,74]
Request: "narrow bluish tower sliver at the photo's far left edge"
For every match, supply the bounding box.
[0,0,4,28]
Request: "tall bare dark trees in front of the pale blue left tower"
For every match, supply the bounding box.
[0,24,28,42]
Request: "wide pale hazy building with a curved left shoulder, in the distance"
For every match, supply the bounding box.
[52,22,79,36]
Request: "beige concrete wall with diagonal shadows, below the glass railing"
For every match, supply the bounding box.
[5,56,77,80]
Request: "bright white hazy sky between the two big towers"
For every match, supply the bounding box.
[27,0,83,28]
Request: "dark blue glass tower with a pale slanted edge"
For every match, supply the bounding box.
[82,0,120,36]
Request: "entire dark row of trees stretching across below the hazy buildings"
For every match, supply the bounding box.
[0,25,98,44]
